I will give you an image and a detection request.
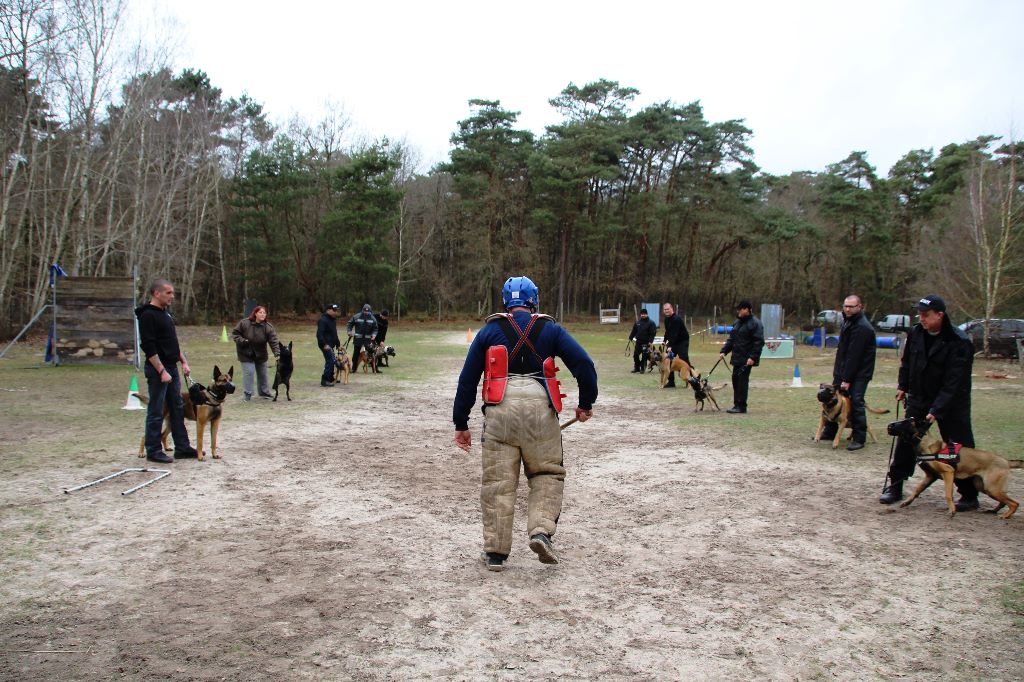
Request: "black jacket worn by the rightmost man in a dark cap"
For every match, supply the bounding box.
[899,318,974,425]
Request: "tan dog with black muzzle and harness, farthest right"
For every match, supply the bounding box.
[889,419,1024,519]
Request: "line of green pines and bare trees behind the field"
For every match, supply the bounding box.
[0,0,1024,333]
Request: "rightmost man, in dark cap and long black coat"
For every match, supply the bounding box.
[879,295,978,503]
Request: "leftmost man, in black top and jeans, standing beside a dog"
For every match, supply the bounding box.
[135,280,199,464]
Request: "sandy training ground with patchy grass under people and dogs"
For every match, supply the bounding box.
[0,323,1024,681]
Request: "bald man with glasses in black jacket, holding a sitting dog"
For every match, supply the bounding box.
[821,295,876,451]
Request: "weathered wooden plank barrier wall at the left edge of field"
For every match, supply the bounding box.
[56,278,135,365]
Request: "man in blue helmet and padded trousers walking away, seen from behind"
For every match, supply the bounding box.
[452,276,597,571]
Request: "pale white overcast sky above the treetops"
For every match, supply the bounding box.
[148,0,1024,174]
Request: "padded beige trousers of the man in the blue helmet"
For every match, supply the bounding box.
[480,377,565,554]
